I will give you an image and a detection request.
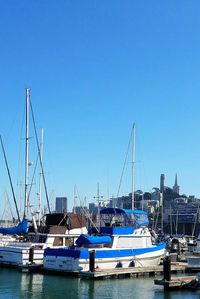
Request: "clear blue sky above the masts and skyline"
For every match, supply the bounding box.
[0,0,200,216]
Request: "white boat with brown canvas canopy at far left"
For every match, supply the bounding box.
[0,213,87,267]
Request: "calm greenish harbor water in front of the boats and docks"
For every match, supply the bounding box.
[0,268,200,299]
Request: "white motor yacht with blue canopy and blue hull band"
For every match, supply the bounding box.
[43,208,166,272]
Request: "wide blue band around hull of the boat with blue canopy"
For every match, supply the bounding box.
[44,243,165,259]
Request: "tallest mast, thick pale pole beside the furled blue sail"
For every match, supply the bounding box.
[24,88,30,218]
